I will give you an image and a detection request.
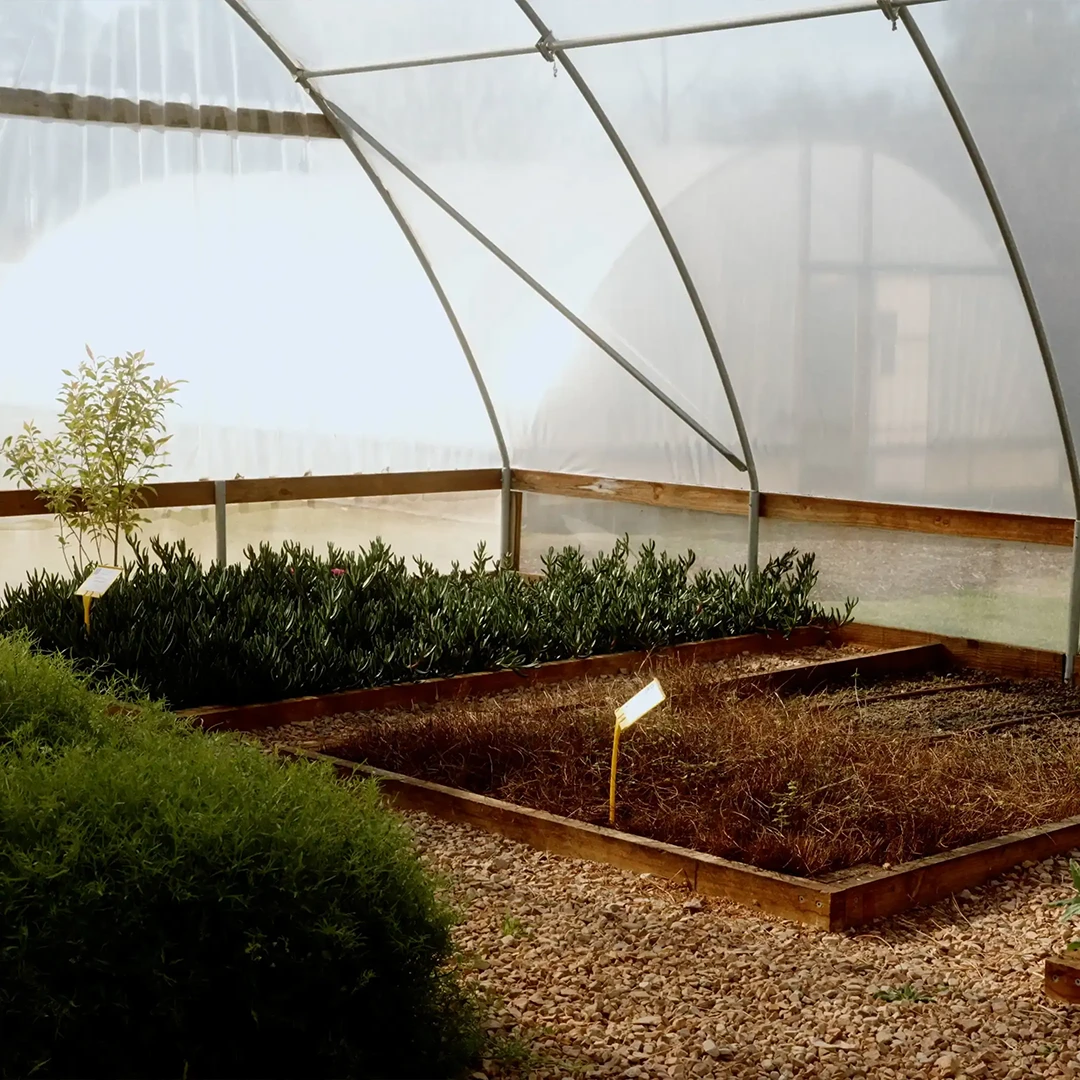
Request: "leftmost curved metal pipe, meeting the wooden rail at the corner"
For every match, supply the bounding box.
[226,0,513,558]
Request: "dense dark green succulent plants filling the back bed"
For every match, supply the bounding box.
[0,539,853,708]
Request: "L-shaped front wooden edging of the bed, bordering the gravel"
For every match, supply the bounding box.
[279,747,1080,931]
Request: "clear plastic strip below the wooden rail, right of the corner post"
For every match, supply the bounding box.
[522,495,1071,651]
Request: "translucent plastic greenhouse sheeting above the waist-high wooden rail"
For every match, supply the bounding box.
[0,0,1080,516]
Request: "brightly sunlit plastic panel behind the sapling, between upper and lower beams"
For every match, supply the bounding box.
[0,127,499,480]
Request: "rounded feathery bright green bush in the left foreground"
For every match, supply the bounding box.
[0,638,478,1077]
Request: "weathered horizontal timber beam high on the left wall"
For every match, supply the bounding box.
[0,86,339,138]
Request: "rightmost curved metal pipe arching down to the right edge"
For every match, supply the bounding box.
[896,6,1080,683]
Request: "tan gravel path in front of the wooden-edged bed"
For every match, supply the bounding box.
[408,814,1080,1080]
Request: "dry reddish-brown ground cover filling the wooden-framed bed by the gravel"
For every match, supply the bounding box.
[252,651,1080,876]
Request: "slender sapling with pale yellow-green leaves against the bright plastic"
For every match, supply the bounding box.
[0,346,179,571]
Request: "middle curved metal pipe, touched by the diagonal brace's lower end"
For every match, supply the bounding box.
[516,0,761,573]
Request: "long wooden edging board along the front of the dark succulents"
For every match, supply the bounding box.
[180,626,826,731]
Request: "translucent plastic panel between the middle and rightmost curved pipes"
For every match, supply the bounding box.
[558,7,1070,513]
